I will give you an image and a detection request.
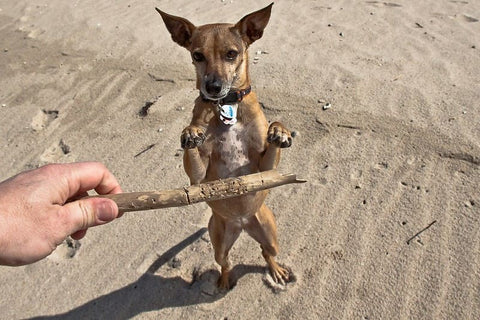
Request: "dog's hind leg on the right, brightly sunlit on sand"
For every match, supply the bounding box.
[244,204,290,284]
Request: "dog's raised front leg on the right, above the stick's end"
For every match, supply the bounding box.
[260,122,292,171]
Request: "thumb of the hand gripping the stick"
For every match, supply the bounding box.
[62,198,118,235]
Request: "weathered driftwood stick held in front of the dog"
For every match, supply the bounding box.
[88,170,306,212]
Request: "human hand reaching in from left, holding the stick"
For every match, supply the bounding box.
[0,162,122,266]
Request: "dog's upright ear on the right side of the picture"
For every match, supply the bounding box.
[235,2,273,45]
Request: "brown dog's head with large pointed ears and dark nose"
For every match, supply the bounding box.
[155,3,273,100]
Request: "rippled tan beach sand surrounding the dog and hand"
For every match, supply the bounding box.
[0,0,480,320]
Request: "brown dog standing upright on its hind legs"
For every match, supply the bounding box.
[156,3,292,289]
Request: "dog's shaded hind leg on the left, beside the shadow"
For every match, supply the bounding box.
[208,212,242,289]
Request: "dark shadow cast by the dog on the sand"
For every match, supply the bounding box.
[33,228,265,319]
